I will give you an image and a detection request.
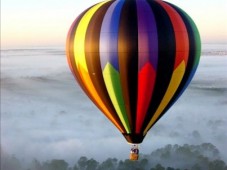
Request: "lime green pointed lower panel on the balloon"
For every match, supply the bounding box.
[103,63,131,133]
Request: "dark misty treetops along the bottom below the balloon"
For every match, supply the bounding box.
[1,143,227,170]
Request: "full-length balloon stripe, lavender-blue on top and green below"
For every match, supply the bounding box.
[100,1,131,133]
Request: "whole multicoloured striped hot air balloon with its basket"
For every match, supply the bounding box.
[66,0,201,159]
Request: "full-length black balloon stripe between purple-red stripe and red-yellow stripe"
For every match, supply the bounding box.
[143,0,176,130]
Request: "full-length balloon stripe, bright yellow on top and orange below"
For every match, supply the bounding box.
[74,1,124,132]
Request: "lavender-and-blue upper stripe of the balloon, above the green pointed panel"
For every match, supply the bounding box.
[99,0,124,70]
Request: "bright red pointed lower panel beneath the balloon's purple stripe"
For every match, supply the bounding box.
[136,63,156,133]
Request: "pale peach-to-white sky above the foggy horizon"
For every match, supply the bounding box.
[1,0,227,48]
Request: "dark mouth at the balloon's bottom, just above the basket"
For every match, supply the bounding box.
[122,133,145,144]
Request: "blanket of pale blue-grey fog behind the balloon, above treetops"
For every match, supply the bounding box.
[1,45,227,162]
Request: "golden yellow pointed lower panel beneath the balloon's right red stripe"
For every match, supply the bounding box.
[144,61,185,134]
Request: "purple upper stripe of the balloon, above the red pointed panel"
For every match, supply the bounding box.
[136,0,158,70]
